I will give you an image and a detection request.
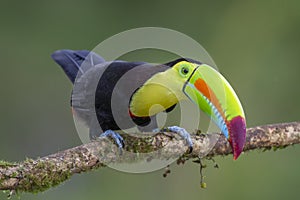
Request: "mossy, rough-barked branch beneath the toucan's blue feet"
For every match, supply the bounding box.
[0,122,300,193]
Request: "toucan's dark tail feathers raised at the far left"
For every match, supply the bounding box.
[51,49,105,83]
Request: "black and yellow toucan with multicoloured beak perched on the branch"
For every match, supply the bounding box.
[51,49,246,160]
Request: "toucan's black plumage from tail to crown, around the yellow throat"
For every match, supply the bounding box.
[52,50,183,138]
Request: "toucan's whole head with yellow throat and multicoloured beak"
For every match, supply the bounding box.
[130,60,246,159]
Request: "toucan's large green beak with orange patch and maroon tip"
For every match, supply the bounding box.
[183,64,246,160]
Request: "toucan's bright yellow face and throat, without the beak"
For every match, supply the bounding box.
[130,61,197,117]
